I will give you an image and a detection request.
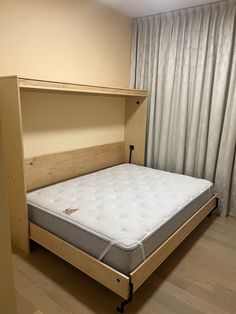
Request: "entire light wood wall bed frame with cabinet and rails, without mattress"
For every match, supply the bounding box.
[0,76,217,312]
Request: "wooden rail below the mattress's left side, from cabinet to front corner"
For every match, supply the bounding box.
[30,223,129,299]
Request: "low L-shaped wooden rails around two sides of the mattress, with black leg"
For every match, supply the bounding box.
[29,195,218,313]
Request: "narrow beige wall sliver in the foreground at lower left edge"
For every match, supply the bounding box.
[0,121,16,314]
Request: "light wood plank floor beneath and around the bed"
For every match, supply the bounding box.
[13,217,236,314]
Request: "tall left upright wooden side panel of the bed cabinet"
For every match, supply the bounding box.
[0,77,29,253]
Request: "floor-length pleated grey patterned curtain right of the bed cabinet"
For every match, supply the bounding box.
[131,1,236,216]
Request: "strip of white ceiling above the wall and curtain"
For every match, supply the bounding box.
[98,0,222,17]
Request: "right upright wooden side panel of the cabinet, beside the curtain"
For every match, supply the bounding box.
[125,97,147,166]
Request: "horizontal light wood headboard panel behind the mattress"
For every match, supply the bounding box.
[25,142,125,191]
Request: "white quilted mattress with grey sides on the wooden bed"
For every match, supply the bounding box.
[27,164,213,275]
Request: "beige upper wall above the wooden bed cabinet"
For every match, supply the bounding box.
[0,0,131,87]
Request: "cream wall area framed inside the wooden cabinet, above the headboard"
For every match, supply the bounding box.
[21,91,125,157]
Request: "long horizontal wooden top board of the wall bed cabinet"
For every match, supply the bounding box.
[5,76,147,97]
